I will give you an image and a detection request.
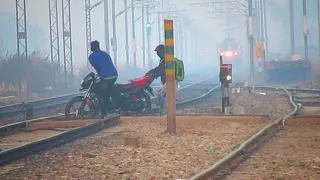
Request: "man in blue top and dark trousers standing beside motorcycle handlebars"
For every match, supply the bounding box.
[89,41,118,117]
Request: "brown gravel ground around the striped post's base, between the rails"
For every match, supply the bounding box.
[0,117,270,180]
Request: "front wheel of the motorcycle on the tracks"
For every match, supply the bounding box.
[65,96,96,120]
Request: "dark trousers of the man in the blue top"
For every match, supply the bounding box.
[97,77,117,116]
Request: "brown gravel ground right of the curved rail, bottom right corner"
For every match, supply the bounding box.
[228,118,320,180]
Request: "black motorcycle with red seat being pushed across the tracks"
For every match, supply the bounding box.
[65,72,154,119]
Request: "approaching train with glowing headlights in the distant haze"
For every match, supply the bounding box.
[217,36,244,72]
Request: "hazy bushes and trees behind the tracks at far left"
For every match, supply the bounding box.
[0,51,75,95]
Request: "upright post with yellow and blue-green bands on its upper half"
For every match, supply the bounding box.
[164,19,176,133]
